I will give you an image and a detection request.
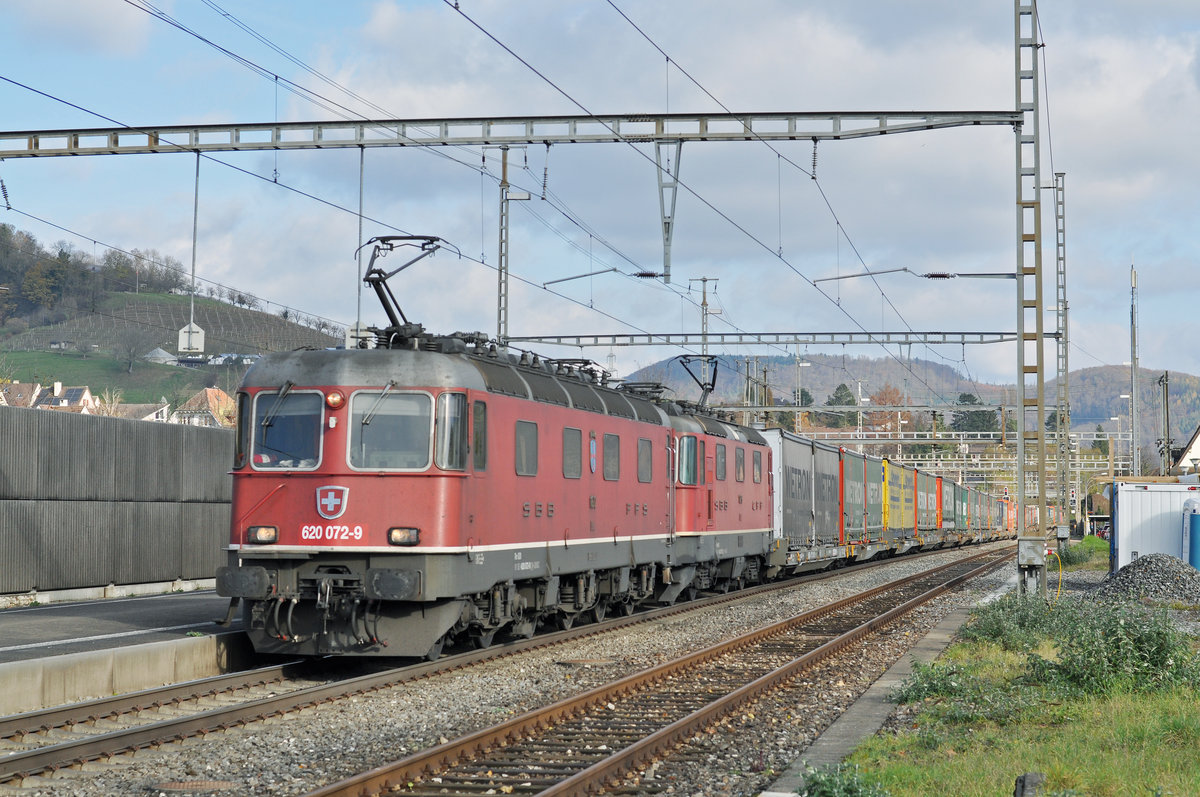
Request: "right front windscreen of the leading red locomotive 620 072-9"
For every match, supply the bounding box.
[349,385,433,471]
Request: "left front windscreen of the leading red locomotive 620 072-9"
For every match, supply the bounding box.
[252,382,325,469]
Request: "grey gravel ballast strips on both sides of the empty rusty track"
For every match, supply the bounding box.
[4,549,1017,797]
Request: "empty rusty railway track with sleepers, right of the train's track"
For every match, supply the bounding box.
[310,552,1010,797]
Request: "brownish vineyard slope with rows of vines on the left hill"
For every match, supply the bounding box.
[4,293,343,354]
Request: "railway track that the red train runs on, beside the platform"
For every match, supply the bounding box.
[0,544,1012,793]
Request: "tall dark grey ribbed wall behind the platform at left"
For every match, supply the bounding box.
[0,407,233,594]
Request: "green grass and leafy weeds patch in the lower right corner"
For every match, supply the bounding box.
[849,594,1200,797]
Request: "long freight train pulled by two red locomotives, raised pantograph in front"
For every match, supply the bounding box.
[217,238,1014,659]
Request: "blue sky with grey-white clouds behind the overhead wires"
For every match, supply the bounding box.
[0,0,1200,405]
